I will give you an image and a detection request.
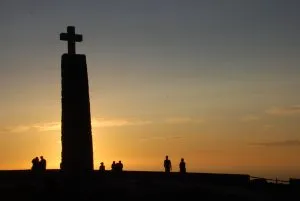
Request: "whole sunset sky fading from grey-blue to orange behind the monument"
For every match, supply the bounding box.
[0,0,300,179]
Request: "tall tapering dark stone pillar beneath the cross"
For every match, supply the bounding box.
[61,54,93,173]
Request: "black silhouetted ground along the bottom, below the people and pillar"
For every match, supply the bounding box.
[0,170,300,201]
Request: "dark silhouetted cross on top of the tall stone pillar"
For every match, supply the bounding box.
[60,26,82,54]
